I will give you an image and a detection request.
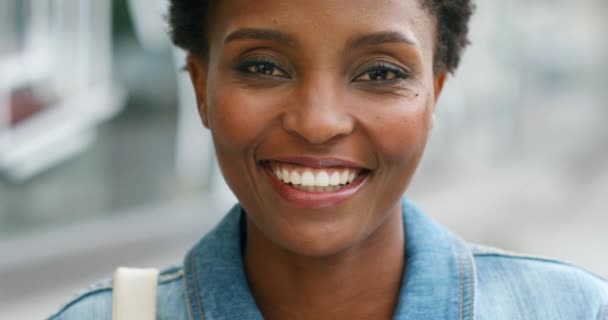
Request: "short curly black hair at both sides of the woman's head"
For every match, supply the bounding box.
[167,0,475,73]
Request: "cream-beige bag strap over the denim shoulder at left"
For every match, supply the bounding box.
[112,268,158,320]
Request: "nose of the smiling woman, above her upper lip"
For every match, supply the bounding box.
[283,78,354,145]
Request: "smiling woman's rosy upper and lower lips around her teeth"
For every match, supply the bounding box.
[262,158,370,209]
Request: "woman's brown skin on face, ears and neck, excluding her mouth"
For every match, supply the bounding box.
[188,0,446,319]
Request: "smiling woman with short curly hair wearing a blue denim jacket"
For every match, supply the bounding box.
[53,0,608,320]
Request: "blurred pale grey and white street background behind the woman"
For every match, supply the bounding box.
[0,0,608,319]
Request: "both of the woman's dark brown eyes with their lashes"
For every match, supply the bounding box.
[236,58,410,82]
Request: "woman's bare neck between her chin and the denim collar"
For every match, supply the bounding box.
[245,206,405,320]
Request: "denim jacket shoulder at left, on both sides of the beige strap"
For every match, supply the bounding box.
[48,266,186,320]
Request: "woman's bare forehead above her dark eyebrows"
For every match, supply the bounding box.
[208,0,435,52]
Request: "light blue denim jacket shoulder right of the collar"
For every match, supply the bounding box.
[471,245,608,320]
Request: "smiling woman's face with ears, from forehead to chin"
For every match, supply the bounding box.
[188,0,445,256]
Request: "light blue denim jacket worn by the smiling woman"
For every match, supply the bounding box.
[50,199,608,320]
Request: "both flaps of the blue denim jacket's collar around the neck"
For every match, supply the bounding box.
[184,199,474,320]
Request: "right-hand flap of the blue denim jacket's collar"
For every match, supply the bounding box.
[394,199,474,320]
